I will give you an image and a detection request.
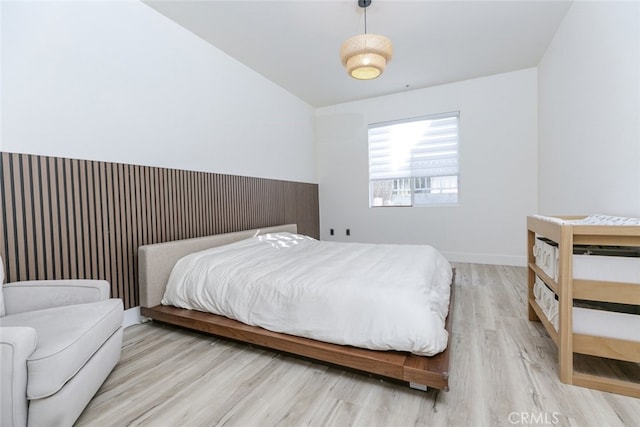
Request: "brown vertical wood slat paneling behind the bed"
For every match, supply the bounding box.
[0,152,319,308]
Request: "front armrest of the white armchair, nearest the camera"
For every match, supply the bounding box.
[0,326,38,426]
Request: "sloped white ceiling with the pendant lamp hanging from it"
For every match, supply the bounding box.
[144,0,571,107]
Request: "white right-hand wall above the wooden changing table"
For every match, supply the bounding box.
[538,1,640,216]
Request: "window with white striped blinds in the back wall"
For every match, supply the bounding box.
[369,112,459,207]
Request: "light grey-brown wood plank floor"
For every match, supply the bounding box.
[77,264,640,427]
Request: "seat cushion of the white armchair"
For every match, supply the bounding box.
[0,299,123,399]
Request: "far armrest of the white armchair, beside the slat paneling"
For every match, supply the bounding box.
[3,279,109,315]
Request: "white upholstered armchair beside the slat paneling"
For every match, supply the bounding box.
[0,258,123,427]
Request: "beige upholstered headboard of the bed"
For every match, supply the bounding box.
[138,224,298,307]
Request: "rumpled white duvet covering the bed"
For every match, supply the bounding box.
[162,233,452,356]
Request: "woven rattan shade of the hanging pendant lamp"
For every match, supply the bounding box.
[340,34,393,80]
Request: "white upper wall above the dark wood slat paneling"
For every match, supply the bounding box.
[0,1,316,182]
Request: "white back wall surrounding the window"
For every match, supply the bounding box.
[316,68,537,265]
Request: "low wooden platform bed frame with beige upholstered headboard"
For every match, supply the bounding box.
[138,224,455,391]
